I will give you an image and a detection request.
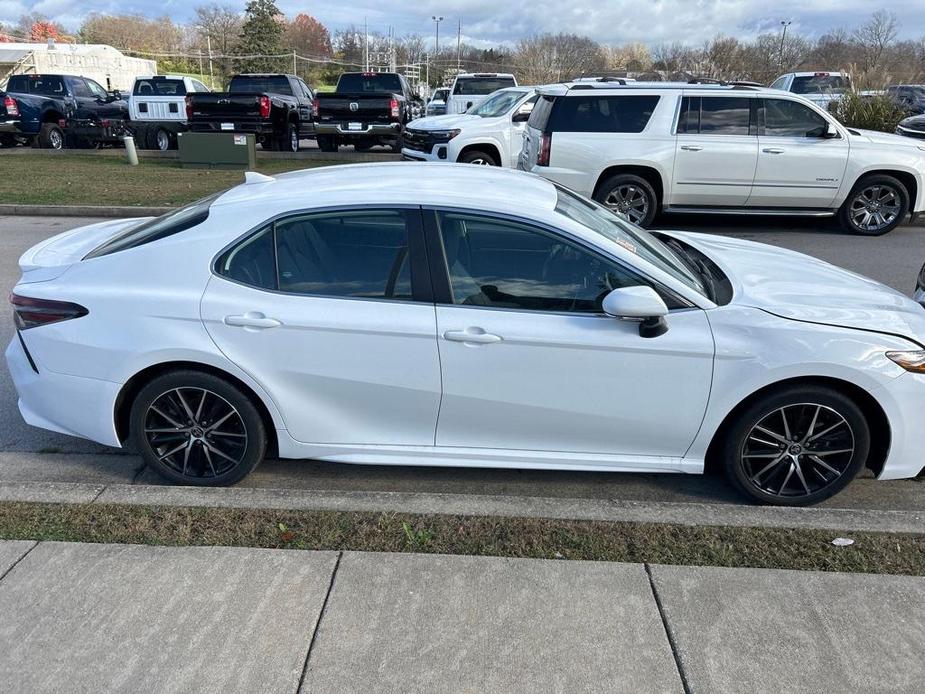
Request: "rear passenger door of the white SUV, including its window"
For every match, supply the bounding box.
[668,94,758,207]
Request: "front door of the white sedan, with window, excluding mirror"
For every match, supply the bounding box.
[428,210,713,469]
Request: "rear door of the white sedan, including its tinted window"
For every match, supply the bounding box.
[201,208,440,446]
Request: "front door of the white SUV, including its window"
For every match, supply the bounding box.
[748,98,848,208]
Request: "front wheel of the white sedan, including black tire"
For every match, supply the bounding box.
[722,386,870,506]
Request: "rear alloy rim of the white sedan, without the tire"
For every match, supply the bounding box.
[144,387,247,478]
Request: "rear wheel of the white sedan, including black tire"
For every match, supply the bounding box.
[129,370,267,487]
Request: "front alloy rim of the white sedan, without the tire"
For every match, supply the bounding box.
[741,403,855,498]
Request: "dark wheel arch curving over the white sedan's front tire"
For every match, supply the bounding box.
[704,376,892,476]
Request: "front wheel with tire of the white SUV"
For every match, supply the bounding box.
[838,175,909,236]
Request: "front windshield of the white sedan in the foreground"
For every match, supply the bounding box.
[556,186,709,296]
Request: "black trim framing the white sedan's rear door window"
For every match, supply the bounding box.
[209,203,435,306]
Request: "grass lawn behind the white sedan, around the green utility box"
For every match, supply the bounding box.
[0,153,332,206]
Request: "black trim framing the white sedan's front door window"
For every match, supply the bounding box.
[422,205,702,319]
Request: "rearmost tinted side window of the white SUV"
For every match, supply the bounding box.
[547,95,659,133]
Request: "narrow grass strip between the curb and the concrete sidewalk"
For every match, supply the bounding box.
[0,502,925,575]
